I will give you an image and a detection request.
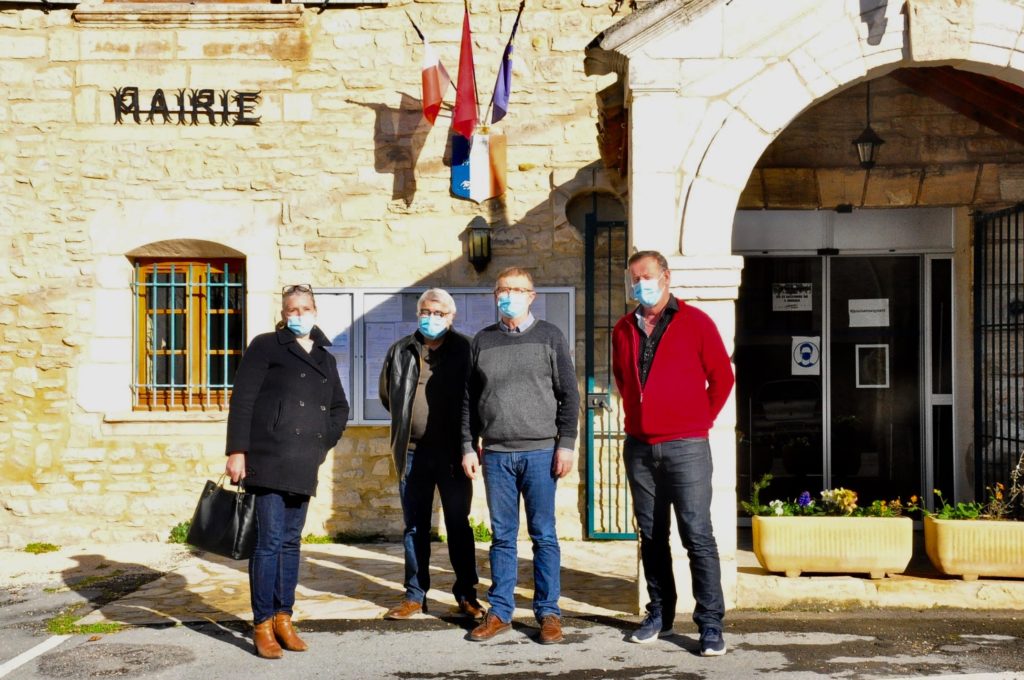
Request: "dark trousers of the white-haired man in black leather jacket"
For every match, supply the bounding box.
[398,449,478,603]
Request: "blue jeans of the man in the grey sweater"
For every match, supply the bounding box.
[483,449,562,623]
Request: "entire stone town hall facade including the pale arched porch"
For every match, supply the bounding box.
[6,0,1024,608]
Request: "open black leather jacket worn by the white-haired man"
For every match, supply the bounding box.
[380,329,469,479]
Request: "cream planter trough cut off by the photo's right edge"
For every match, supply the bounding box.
[925,516,1024,581]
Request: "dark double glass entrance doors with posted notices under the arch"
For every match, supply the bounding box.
[734,256,925,501]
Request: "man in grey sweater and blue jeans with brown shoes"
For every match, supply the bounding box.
[462,267,580,644]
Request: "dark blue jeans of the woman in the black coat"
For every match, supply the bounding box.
[248,486,309,624]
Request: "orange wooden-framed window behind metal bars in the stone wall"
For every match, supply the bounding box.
[132,258,246,411]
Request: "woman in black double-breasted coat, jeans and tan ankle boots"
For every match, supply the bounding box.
[225,286,348,658]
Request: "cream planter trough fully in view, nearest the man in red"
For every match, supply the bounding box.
[751,517,913,579]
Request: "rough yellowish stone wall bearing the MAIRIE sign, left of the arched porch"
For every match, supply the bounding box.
[0,0,626,546]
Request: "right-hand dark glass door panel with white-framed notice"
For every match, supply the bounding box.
[826,257,922,501]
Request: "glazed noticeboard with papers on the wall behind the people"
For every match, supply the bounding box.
[316,287,575,425]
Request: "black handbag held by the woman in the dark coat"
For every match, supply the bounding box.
[186,475,256,559]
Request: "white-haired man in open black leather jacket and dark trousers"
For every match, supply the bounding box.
[380,288,483,621]
